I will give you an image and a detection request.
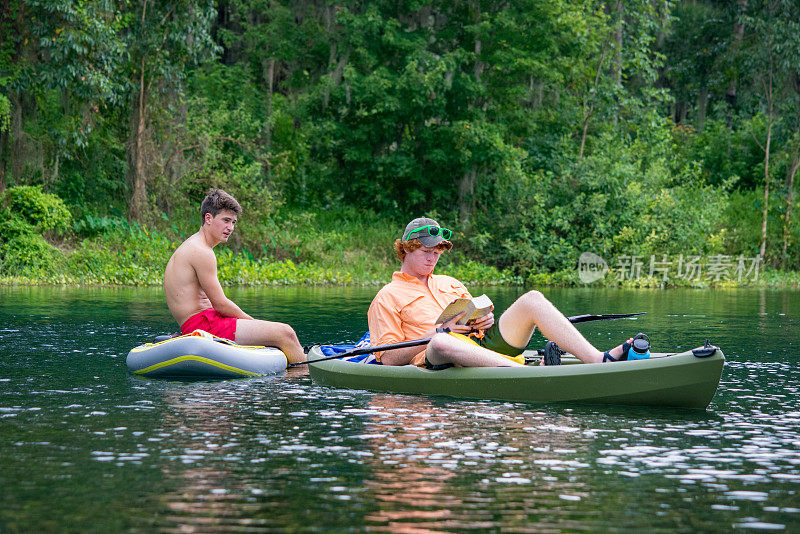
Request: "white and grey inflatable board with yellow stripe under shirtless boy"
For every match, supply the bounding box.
[126,330,287,378]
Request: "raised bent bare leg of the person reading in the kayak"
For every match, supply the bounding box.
[498,291,622,363]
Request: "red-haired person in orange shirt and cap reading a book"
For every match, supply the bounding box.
[368,217,631,369]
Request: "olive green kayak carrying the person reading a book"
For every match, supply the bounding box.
[308,346,725,409]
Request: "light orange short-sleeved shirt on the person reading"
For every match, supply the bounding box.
[367,272,472,366]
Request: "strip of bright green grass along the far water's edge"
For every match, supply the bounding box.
[0,212,800,288]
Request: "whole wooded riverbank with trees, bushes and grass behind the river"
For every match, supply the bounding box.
[0,0,800,287]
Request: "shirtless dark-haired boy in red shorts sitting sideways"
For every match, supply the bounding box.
[164,189,306,363]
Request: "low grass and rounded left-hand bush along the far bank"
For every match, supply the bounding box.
[0,186,800,288]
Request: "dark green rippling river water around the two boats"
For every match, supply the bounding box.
[0,288,800,533]
